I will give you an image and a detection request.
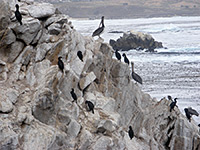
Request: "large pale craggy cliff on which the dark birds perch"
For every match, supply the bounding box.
[0,1,200,150]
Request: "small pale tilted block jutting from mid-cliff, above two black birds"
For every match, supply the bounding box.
[79,72,96,90]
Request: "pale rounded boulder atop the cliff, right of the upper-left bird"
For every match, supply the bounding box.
[27,3,56,19]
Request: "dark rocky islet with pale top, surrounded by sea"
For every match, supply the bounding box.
[110,31,163,52]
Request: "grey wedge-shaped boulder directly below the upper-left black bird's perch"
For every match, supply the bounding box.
[13,18,41,45]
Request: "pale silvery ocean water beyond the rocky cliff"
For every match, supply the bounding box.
[72,17,200,124]
